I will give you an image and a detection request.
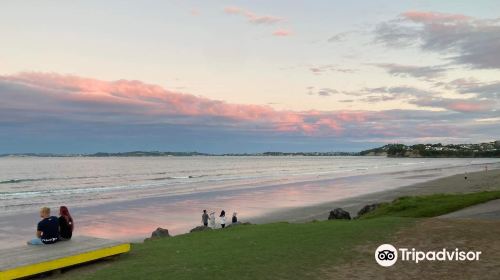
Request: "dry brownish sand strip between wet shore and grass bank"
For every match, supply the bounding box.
[249,166,500,224]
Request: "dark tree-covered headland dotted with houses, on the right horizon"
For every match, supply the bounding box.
[360,141,500,158]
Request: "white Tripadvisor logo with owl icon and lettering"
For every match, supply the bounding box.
[375,244,481,267]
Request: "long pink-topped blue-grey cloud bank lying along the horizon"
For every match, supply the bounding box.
[0,73,500,151]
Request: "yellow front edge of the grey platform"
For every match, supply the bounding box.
[0,243,130,280]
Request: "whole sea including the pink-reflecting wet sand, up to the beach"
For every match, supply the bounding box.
[0,157,500,247]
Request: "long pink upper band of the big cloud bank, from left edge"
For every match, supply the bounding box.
[0,73,381,135]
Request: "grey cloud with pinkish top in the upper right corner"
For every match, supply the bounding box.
[376,11,500,69]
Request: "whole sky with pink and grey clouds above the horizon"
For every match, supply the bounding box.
[0,0,500,153]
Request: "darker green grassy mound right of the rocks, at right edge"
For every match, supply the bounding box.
[361,191,500,219]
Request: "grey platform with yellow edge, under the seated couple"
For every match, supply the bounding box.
[0,236,130,280]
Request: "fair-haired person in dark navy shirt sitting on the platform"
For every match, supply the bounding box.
[28,207,59,245]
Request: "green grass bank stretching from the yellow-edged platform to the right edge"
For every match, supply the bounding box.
[58,191,500,280]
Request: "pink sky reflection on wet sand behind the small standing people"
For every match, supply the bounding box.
[78,172,432,239]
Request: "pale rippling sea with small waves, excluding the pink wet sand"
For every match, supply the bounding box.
[0,157,494,213]
